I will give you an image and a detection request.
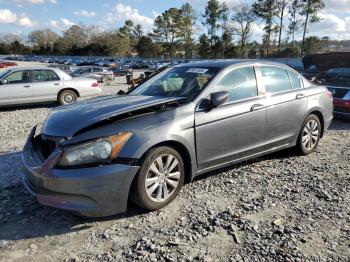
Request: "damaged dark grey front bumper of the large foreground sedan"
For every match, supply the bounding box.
[22,127,139,217]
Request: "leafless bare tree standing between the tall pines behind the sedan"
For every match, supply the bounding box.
[231,3,257,49]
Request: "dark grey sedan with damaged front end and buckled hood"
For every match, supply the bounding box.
[22,60,333,216]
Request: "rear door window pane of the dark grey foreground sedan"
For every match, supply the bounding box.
[260,66,292,93]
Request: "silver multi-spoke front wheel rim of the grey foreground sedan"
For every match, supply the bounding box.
[145,154,181,202]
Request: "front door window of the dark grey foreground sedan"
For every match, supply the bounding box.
[213,66,258,102]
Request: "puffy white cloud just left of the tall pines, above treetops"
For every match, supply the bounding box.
[106,4,153,29]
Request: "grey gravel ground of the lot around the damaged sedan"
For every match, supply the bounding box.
[0,62,350,261]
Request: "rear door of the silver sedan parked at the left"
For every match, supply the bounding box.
[32,69,63,101]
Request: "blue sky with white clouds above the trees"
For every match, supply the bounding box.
[0,0,350,42]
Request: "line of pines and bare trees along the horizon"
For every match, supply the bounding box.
[0,0,324,58]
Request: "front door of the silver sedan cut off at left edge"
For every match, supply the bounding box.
[0,70,32,105]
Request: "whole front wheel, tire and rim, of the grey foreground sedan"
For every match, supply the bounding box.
[130,146,185,210]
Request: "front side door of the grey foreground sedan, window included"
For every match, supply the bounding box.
[195,66,266,170]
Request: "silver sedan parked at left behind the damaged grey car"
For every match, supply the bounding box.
[0,67,101,106]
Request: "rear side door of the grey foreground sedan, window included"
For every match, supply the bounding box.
[259,66,307,150]
